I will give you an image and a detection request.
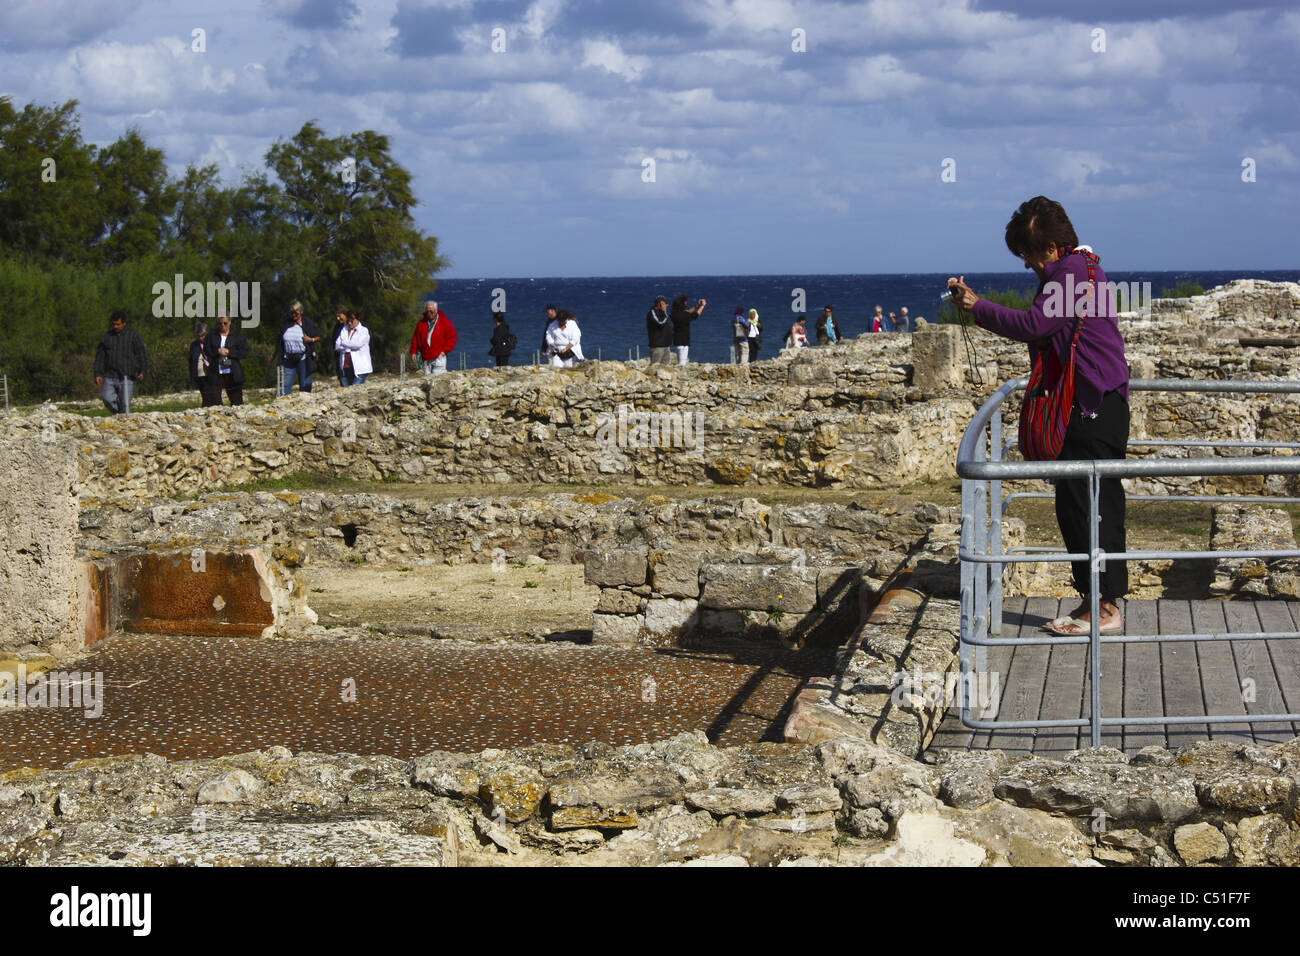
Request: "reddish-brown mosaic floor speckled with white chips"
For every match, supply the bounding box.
[0,635,833,769]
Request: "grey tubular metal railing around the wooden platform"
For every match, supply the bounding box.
[957,377,1300,747]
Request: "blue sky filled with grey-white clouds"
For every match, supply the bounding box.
[0,0,1300,277]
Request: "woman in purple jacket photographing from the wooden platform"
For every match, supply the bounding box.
[948,196,1128,635]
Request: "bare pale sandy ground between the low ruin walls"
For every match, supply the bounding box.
[300,564,601,641]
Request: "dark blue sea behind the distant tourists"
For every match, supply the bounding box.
[426,269,1300,368]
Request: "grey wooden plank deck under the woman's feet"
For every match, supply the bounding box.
[931,597,1300,757]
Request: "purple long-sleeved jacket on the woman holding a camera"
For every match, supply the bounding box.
[974,252,1128,415]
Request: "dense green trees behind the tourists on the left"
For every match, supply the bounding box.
[0,98,446,403]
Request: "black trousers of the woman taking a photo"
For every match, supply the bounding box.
[1056,392,1128,602]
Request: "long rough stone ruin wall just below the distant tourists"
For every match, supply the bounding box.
[8,282,1300,499]
